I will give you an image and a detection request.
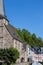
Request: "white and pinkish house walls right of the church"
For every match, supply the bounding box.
[28,48,43,62]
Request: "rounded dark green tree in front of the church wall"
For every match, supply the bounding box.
[0,48,19,65]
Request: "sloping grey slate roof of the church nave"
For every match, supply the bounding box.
[5,24,23,42]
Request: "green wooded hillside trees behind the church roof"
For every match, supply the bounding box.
[17,29,43,47]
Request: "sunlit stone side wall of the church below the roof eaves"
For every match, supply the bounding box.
[14,39,28,62]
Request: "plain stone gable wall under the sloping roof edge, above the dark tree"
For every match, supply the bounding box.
[3,19,13,48]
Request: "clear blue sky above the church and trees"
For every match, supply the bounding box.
[4,0,43,38]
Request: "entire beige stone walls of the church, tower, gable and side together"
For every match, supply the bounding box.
[0,19,28,62]
